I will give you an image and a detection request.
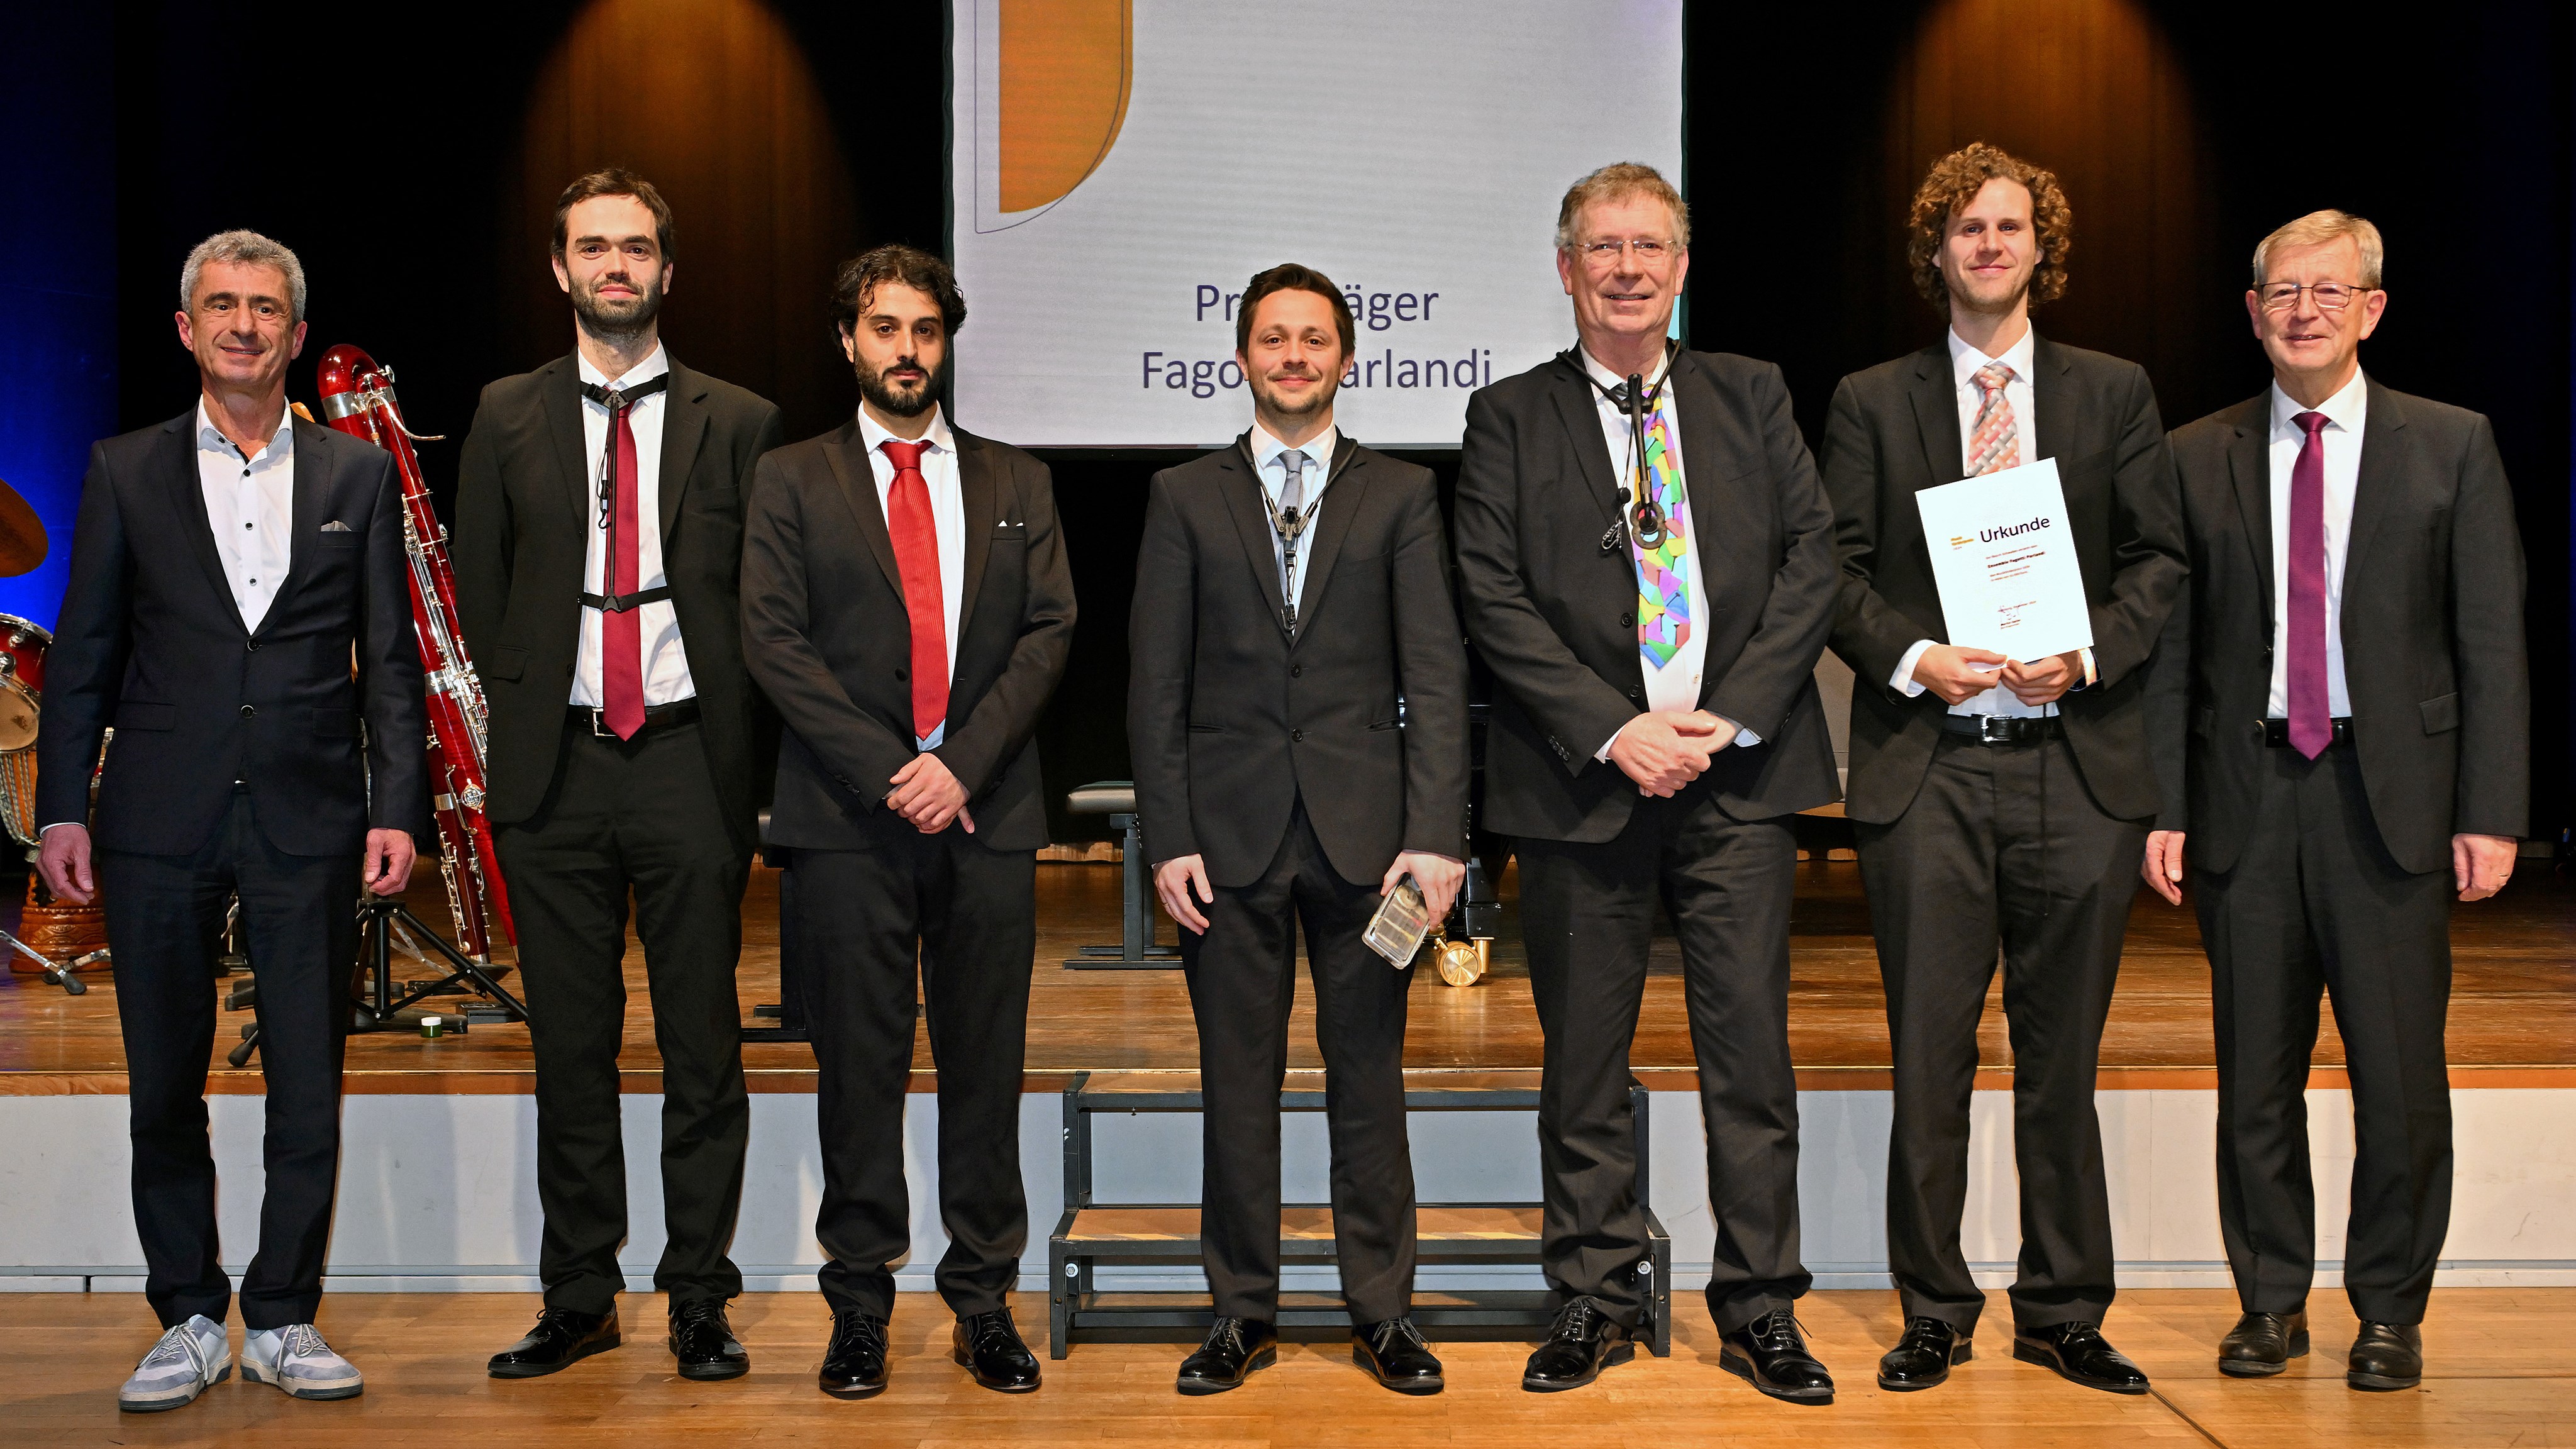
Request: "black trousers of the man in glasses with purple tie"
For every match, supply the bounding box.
[2184,745,2452,1323]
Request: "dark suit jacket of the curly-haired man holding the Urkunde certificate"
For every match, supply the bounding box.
[1824,338,2184,825]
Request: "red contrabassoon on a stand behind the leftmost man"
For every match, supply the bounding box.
[317,343,518,962]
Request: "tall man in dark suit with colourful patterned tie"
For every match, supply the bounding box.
[1458,165,1834,1402]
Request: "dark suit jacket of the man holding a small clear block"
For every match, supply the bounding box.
[1128,436,1466,887]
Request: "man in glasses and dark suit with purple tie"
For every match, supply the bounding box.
[2143,211,2532,1390]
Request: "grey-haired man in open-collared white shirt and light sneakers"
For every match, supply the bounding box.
[36,232,428,1413]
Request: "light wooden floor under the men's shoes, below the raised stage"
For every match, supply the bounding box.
[0,1289,2576,1449]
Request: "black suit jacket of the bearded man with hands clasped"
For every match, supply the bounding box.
[742,420,1074,851]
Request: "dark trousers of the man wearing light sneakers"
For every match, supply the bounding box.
[96,792,358,1328]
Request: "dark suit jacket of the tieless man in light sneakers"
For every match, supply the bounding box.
[36,408,428,856]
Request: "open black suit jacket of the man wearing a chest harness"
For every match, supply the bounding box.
[451,356,778,851]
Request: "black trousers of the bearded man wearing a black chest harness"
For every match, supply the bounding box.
[494,722,752,1313]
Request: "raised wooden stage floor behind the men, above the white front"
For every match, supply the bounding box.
[0,861,2576,1096]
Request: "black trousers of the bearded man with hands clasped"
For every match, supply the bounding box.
[778,825,1038,1318]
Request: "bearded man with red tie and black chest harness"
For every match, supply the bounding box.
[456,170,778,1379]
